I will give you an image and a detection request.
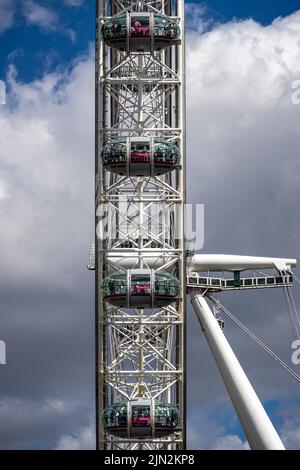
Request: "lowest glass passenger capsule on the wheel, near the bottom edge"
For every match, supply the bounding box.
[102,398,179,439]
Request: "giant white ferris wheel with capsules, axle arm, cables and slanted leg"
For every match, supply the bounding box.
[88,0,300,450]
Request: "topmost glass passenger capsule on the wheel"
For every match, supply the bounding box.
[102,12,180,52]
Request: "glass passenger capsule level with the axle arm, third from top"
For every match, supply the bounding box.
[101,269,179,308]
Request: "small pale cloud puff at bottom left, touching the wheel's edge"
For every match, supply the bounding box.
[54,424,96,450]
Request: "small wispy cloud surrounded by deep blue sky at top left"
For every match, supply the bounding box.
[23,0,75,41]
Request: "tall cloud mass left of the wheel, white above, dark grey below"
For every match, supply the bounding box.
[0,51,94,448]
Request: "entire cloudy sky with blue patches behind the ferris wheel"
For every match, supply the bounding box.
[0,0,300,449]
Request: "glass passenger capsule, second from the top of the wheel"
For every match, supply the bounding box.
[101,137,180,176]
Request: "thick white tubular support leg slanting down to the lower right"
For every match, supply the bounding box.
[190,290,284,450]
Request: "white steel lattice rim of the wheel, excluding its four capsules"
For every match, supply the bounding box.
[95,0,186,449]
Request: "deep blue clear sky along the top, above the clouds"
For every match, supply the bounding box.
[0,0,299,81]
